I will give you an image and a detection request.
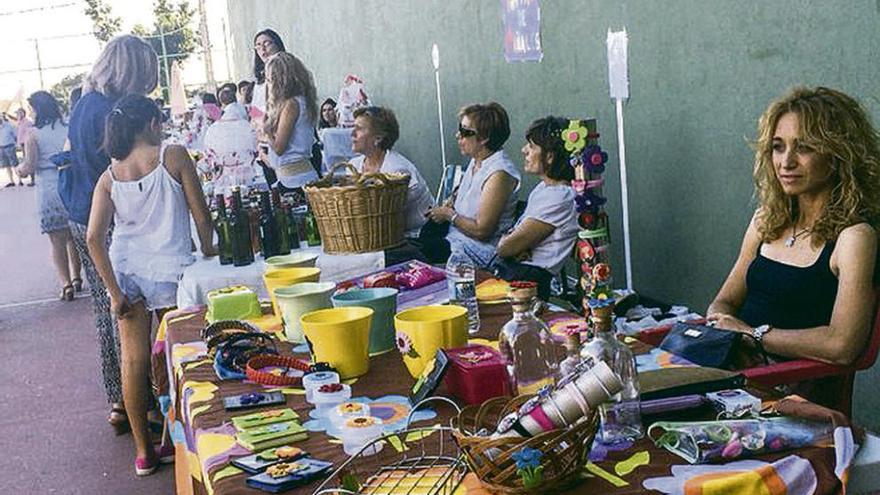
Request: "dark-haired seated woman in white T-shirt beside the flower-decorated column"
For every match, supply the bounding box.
[492,117,578,300]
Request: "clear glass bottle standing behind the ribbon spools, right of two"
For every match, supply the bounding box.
[581,298,645,444]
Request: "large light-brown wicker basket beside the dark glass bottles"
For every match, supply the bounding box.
[304,162,410,254]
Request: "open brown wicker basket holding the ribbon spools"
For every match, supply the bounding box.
[452,395,599,494]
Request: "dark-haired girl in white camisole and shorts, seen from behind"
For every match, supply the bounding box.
[87,95,215,476]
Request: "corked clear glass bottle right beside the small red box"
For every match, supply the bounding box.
[498,282,559,395]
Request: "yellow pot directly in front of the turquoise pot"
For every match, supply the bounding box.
[300,306,373,379]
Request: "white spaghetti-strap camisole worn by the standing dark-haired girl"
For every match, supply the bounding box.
[109,143,195,282]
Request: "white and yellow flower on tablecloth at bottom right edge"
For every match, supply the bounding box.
[642,455,818,495]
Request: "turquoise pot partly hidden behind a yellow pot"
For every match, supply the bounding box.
[330,287,397,356]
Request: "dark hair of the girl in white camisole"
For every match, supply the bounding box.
[103,95,162,160]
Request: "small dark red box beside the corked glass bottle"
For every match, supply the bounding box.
[446,344,508,404]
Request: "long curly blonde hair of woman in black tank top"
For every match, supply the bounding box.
[753,87,880,245]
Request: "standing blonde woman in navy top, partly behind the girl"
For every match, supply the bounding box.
[58,35,159,434]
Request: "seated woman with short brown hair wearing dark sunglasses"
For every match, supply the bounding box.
[423,102,520,268]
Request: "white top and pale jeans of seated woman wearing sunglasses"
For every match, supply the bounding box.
[446,150,522,267]
